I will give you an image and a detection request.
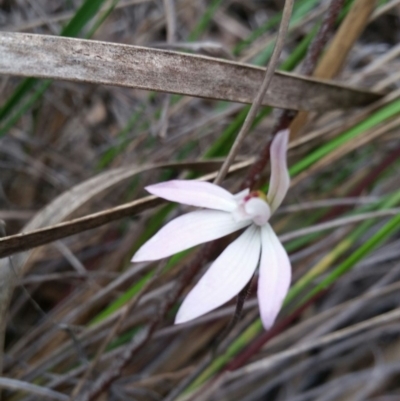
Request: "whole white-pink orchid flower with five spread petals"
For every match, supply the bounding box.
[132,130,291,329]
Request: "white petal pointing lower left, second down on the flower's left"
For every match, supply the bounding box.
[132,210,251,262]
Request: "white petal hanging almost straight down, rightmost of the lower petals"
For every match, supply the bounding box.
[258,224,292,330]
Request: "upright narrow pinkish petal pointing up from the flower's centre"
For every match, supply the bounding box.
[267,130,290,213]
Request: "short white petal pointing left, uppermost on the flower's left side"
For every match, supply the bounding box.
[146,180,237,212]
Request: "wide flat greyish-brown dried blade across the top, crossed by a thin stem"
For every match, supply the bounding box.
[0,32,382,111]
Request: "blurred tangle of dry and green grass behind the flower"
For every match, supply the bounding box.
[0,0,400,401]
